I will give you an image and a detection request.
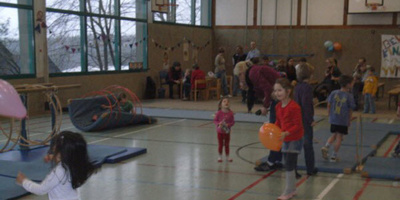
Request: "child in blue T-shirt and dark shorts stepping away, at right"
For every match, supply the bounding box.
[321,75,356,162]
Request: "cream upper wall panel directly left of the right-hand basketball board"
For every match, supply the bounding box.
[301,0,344,25]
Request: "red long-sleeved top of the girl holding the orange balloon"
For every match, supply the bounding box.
[275,100,304,142]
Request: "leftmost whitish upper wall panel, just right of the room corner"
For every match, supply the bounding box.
[215,0,254,26]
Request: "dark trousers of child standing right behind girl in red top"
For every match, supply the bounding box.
[303,123,315,174]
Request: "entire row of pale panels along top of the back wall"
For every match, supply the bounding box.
[216,0,400,26]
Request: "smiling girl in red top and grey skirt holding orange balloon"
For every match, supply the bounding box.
[274,78,304,199]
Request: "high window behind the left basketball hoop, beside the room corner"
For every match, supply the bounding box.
[153,0,211,26]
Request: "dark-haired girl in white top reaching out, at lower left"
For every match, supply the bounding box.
[16,131,95,200]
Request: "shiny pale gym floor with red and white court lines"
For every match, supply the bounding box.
[5,98,400,200]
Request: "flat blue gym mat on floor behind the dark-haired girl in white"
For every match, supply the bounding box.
[0,145,147,199]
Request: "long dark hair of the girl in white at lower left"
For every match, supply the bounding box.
[52,131,96,189]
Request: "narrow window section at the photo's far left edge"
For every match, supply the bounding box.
[0,0,35,76]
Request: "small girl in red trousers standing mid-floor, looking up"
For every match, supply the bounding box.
[214,98,235,162]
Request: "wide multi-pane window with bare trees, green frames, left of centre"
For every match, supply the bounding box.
[47,0,147,72]
